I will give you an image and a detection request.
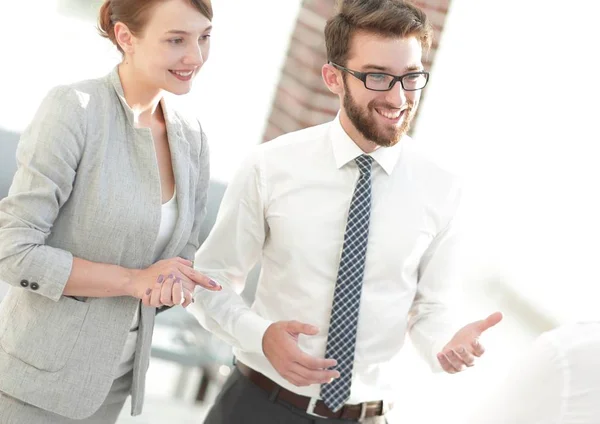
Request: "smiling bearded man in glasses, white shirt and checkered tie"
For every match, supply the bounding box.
[192,0,501,424]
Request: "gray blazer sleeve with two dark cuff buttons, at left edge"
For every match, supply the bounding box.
[0,86,89,301]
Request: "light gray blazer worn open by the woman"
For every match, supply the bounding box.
[0,68,209,419]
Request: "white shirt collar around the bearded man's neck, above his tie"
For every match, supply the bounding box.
[329,113,402,175]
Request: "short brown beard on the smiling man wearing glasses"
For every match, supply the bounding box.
[344,86,415,147]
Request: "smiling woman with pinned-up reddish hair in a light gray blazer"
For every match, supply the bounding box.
[0,0,220,424]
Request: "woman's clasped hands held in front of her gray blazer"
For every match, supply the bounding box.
[128,258,221,308]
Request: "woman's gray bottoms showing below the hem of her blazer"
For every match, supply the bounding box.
[0,371,133,424]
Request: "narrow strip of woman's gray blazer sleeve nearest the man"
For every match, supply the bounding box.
[180,122,210,261]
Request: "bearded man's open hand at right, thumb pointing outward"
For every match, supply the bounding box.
[437,312,502,374]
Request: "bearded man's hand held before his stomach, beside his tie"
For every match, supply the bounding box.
[262,321,340,387]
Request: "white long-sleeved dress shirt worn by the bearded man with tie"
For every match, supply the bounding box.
[188,117,460,404]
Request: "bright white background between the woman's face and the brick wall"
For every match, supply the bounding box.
[194,0,301,181]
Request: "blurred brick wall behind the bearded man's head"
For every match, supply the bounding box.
[263,0,450,141]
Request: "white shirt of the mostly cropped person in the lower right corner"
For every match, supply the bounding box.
[468,322,600,424]
